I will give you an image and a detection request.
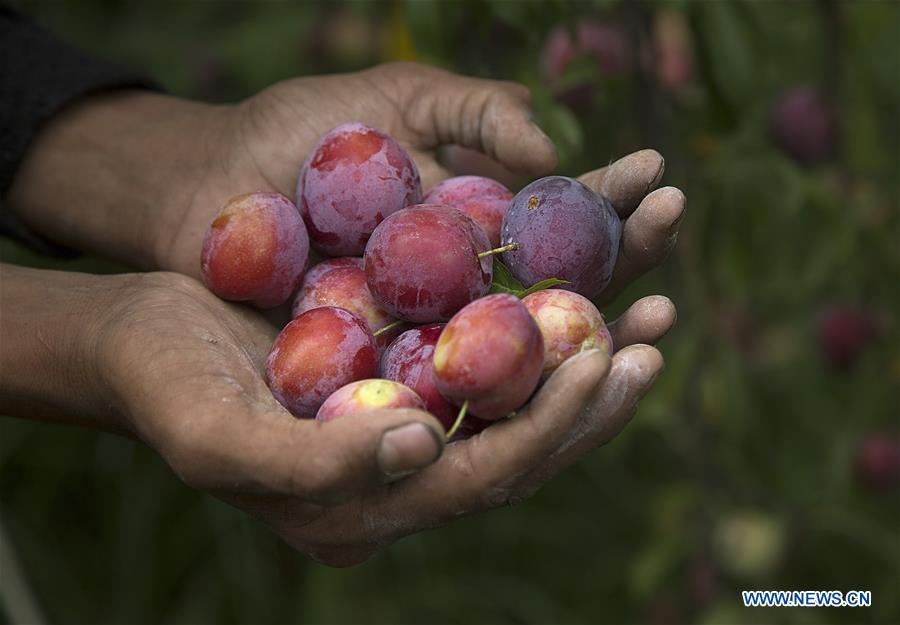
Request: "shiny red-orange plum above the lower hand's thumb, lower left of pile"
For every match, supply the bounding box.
[266,306,378,419]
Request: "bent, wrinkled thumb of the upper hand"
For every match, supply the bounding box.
[390,64,557,175]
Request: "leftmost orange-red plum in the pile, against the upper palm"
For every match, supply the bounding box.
[200,193,309,308]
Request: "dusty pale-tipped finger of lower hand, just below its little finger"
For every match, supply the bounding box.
[517,345,665,486]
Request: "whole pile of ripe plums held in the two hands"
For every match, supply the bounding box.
[201,123,621,437]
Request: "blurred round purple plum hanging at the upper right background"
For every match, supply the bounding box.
[771,86,835,165]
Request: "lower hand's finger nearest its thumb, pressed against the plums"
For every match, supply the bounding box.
[365,350,610,540]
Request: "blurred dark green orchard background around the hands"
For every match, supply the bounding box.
[0,0,900,624]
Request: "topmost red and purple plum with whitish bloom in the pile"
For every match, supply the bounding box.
[297,123,422,256]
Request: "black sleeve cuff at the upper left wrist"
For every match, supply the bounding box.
[0,6,160,253]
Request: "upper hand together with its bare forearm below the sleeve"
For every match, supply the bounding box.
[8,63,684,294]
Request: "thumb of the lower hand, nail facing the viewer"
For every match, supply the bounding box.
[158,400,444,504]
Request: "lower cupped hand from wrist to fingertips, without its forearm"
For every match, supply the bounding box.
[98,273,674,565]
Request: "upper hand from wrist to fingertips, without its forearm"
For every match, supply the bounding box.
[169,63,684,303]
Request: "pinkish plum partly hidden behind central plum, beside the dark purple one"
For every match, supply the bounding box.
[423,176,513,247]
